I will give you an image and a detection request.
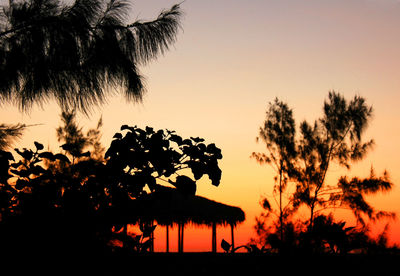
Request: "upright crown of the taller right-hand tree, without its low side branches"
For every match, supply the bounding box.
[294,91,374,227]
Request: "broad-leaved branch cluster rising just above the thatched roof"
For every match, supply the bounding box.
[105,125,222,204]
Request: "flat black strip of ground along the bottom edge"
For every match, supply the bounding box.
[10,253,400,276]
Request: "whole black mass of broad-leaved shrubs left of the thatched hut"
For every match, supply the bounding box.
[0,126,222,255]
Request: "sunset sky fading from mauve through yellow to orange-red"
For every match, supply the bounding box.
[0,0,400,251]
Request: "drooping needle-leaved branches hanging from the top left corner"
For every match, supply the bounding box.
[0,0,182,112]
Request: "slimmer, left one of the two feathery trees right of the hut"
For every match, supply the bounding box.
[252,98,296,246]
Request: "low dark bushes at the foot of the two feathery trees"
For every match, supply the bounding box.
[252,214,399,255]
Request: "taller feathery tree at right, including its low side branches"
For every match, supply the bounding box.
[293,92,392,228]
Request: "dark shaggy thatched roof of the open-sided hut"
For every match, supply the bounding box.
[126,187,245,226]
